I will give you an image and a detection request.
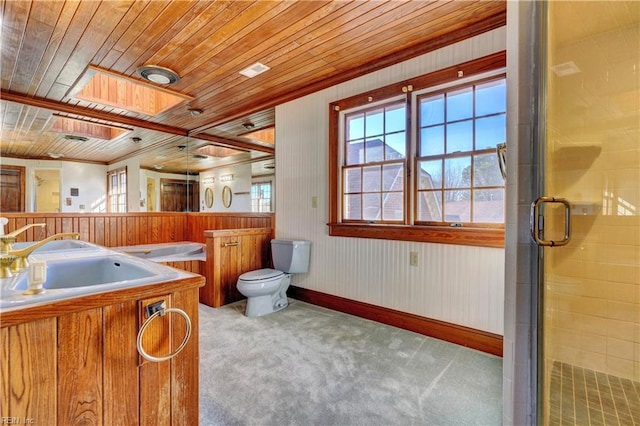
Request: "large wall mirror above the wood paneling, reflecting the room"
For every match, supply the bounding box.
[0,99,275,213]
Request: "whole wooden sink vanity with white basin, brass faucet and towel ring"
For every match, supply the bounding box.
[0,238,204,425]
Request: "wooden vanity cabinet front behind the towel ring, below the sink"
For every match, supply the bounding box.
[0,275,204,426]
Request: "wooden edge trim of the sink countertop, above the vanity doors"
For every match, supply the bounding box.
[0,274,205,328]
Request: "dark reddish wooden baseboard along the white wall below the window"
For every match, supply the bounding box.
[287,286,502,357]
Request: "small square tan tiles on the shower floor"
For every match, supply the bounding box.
[549,361,640,426]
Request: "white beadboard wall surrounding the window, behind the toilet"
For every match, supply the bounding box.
[276,28,506,335]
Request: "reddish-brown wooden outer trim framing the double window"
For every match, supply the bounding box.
[327,51,506,248]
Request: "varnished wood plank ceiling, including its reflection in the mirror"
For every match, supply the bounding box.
[0,0,506,172]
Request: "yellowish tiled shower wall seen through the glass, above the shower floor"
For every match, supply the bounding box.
[545,2,640,381]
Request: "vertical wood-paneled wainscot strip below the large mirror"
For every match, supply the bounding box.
[0,212,274,247]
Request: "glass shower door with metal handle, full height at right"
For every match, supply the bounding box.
[532,1,640,425]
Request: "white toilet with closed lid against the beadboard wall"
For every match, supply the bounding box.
[236,240,311,317]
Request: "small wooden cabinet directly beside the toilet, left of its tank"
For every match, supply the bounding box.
[200,228,273,308]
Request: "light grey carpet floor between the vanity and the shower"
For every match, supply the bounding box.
[200,299,502,426]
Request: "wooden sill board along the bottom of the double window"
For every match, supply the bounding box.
[327,223,504,248]
